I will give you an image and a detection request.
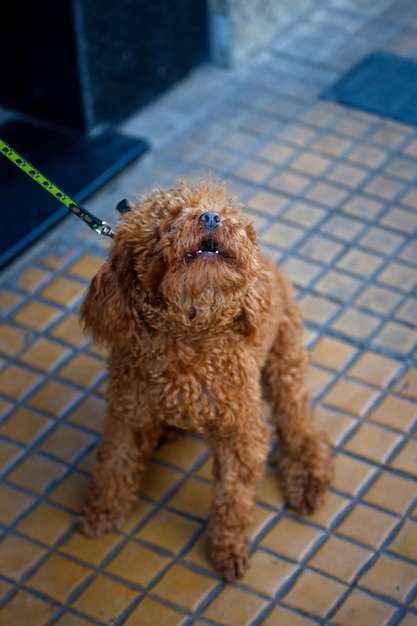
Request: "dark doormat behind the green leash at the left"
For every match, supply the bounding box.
[0,120,149,268]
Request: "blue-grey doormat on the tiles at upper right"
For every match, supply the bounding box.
[322,51,417,126]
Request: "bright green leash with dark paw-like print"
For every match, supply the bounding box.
[0,138,114,237]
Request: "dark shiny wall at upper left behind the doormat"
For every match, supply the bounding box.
[0,0,208,132]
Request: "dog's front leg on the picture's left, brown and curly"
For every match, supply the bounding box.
[79,418,161,537]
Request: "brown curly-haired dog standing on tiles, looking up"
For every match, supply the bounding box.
[80,183,333,581]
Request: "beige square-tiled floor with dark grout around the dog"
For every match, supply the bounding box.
[0,0,417,626]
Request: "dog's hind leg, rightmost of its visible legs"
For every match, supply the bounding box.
[262,303,333,513]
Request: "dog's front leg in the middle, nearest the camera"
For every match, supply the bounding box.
[208,416,269,582]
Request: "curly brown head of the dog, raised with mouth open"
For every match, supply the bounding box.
[81,183,258,343]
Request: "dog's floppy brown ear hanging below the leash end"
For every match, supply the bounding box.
[80,241,138,346]
